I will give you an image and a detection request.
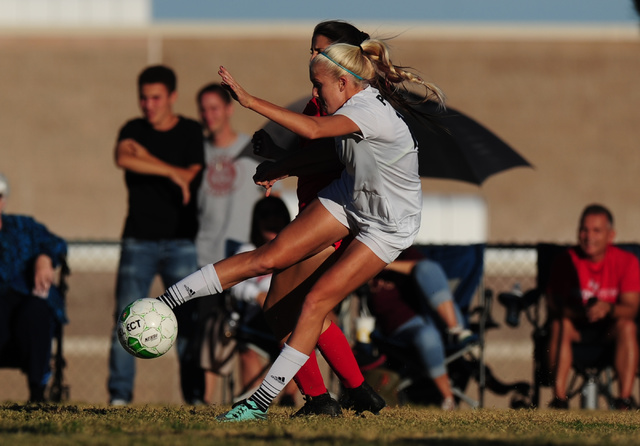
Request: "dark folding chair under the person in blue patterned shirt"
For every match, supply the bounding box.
[0,256,70,403]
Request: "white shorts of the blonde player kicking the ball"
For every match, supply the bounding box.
[318,196,420,264]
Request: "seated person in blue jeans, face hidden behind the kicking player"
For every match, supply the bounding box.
[369,248,472,410]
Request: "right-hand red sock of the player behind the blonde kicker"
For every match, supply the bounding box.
[318,322,364,389]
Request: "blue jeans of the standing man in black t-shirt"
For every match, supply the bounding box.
[107,238,204,403]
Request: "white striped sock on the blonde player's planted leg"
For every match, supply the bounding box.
[249,344,309,412]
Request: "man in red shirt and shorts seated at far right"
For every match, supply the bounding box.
[546,204,640,409]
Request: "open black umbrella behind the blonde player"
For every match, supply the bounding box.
[238,98,531,185]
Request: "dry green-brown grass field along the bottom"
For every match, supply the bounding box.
[0,403,640,446]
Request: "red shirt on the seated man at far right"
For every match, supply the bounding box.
[548,246,640,305]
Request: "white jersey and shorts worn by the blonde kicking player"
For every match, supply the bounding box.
[320,87,422,262]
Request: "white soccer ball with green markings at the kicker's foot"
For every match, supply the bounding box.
[118,297,178,359]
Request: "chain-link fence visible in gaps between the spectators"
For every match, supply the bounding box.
[0,241,556,407]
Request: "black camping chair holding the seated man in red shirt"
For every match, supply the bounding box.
[498,243,640,409]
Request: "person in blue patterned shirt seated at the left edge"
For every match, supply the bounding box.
[0,174,67,402]
